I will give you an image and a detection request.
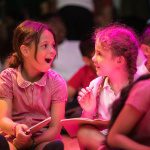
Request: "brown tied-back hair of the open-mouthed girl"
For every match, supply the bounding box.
[8,20,55,68]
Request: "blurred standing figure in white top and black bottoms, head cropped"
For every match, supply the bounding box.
[56,0,94,40]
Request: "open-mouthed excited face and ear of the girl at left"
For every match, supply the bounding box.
[27,30,56,72]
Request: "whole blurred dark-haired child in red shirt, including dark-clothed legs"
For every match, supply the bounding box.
[66,39,97,117]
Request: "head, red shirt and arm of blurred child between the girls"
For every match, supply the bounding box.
[68,39,97,99]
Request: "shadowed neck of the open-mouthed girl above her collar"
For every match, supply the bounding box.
[21,67,43,82]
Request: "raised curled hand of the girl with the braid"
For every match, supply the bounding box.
[78,87,96,113]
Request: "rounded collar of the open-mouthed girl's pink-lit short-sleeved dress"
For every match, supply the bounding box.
[17,66,47,88]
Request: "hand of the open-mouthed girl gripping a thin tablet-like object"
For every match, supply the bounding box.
[13,124,32,149]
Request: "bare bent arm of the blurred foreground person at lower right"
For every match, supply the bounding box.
[107,105,150,150]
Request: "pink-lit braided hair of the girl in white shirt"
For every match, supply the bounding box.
[94,24,139,82]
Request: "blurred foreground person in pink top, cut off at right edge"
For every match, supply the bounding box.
[106,74,150,150]
